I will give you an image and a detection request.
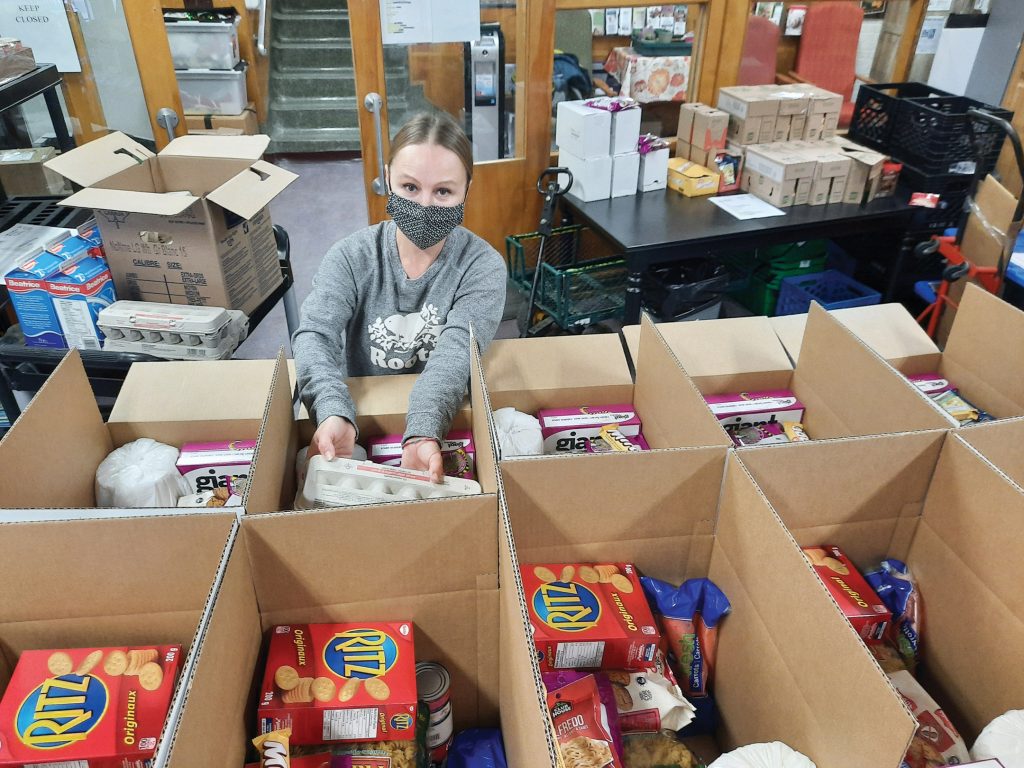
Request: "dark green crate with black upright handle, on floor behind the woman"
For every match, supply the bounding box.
[505,226,627,329]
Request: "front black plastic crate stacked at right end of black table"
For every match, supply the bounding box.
[890,96,1014,175]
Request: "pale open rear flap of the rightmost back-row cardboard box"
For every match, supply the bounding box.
[769,304,939,373]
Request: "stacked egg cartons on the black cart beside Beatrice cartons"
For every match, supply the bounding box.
[97,301,249,359]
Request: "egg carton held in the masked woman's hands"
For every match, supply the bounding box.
[295,456,481,509]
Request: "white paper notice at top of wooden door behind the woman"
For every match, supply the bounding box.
[380,0,480,45]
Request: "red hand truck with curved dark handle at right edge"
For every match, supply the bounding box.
[914,110,1024,339]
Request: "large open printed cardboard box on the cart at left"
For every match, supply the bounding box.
[46,133,297,314]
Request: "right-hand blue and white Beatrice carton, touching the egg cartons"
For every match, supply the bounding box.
[47,256,117,349]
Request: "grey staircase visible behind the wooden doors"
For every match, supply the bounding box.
[267,0,419,154]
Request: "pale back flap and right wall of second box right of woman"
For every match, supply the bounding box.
[644,304,954,442]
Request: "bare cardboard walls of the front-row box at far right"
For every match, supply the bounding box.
[736,432,1024,766]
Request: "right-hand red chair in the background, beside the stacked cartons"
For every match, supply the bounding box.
[778,0,873,128]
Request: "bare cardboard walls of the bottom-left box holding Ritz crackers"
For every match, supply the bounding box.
[0,511,237,765]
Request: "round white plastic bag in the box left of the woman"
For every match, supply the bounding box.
[96,437,190,509]
